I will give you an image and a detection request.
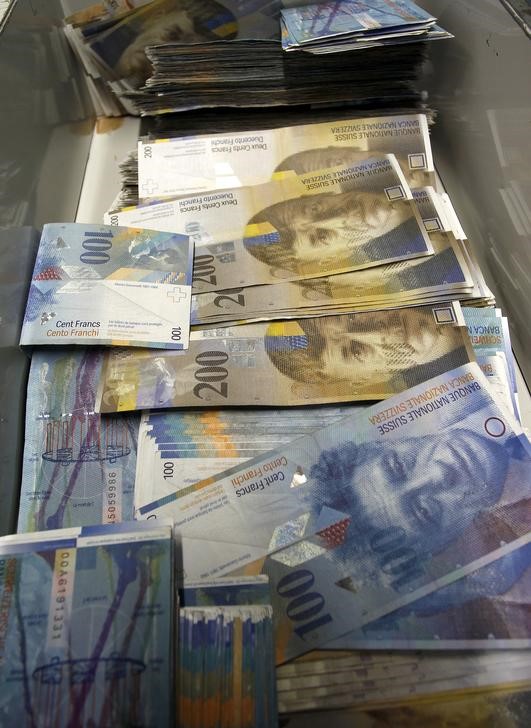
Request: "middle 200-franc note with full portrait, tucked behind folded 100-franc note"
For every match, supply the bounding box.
[105,155,433,292]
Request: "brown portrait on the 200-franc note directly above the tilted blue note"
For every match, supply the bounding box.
[265,309,468,398]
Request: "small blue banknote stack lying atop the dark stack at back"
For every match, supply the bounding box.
[280,0,451,53]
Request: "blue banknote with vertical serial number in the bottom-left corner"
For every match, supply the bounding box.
[0,523,174,728]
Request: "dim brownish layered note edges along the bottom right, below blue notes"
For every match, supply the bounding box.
[277,650,531,712]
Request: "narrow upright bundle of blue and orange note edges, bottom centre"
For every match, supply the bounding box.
[177,577,278,728]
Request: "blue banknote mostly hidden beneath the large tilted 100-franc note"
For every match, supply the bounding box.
[326,544,531,650]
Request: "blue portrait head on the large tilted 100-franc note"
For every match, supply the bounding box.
[310,428,508,553]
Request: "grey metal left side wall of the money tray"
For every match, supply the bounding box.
[0,0,94,534]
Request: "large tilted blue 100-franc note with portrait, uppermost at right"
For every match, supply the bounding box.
[140,363,531,662]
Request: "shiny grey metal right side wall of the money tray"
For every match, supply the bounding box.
[419,0,531,386]
